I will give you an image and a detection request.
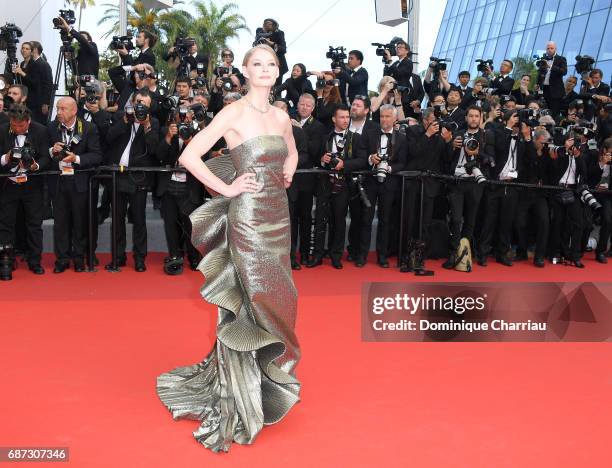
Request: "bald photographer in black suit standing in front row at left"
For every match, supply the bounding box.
[48,97,102,273]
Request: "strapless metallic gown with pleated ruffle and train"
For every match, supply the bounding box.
[157,135,300,452]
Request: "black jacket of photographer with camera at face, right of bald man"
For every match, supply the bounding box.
[104,111,159,192]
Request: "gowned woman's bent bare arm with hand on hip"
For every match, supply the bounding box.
[179,105,262,197]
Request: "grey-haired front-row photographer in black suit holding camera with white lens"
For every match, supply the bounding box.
[358,104,408,268]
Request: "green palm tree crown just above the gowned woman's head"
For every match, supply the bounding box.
[189,0,251,71]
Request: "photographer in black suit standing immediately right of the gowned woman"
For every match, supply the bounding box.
[289,93,327,269]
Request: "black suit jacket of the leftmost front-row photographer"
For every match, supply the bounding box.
[0,121,51,190]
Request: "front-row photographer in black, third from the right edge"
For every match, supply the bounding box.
[514,128,552,268]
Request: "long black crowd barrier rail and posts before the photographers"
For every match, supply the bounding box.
[0,165,612,271]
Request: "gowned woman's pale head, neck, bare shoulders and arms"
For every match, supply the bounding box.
[179,49,298,197]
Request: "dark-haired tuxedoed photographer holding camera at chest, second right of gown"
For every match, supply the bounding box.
[307,104,367,269]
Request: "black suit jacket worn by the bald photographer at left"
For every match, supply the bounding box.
[47,118,102,194]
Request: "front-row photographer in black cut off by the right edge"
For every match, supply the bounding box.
[587,137,612,263]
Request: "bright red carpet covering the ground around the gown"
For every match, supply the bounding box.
[0,254,612,468]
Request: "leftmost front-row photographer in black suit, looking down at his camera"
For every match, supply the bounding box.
[0,104,51,275]
